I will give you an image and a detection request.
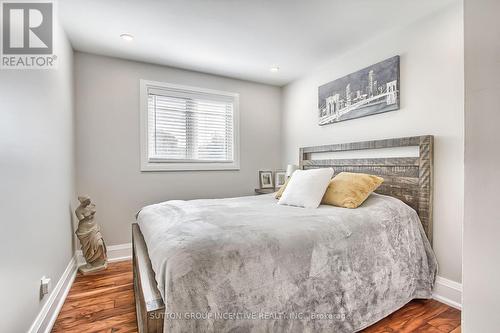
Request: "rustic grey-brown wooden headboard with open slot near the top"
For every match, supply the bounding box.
[299,135,434,244]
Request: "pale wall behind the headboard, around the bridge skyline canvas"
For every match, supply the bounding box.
[281,1,464,282]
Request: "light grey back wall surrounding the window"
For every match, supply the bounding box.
[75,53,280,245]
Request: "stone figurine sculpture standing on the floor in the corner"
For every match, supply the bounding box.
[75,196,108,275]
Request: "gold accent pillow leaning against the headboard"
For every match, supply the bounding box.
[321,172,384,208]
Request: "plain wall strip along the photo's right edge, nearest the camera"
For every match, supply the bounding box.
[462,0,500,333]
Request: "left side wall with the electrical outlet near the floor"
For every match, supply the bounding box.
[0,24,74,333]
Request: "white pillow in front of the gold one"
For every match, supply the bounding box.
[278,168,333,208]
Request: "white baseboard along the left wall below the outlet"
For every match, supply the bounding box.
[28,256,78,333]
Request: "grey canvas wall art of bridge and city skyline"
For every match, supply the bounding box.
[318,56,400,125]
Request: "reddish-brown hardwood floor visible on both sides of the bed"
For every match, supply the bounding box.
[52,261,460,333]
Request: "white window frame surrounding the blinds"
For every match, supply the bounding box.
[139,79,240,171]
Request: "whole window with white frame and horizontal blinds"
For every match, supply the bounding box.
[141,80,239,171]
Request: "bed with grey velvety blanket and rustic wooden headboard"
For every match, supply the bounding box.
[132,136,437,333]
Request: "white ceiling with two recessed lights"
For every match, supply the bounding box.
[58,0,455,85]
